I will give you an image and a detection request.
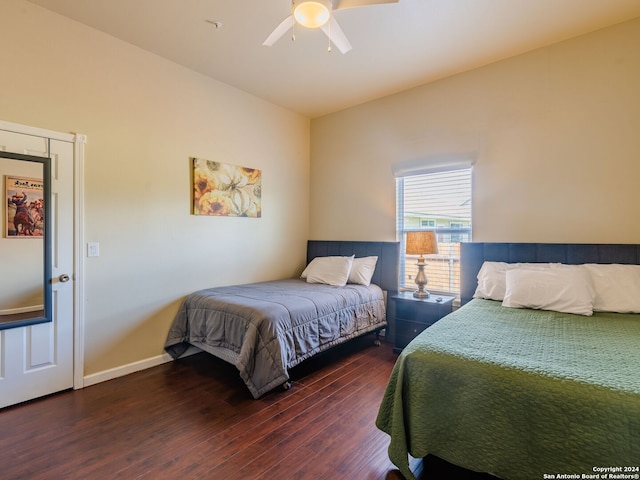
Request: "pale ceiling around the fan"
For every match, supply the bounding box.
[29,0,640,118]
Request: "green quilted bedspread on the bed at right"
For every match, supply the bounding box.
[376,299,640,480]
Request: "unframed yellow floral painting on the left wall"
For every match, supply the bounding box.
[192,158,262,217]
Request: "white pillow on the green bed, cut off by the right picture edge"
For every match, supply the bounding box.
[584,263,640,313]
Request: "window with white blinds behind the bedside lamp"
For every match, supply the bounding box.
[396,166,471,295]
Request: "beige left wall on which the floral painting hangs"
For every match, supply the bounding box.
[0,0,309,375]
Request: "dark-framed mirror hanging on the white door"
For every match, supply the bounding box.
[0,152,52,330]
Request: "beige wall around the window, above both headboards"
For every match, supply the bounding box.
[311,19,640,243]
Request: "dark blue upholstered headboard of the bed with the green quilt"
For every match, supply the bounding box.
[460,242,640,305]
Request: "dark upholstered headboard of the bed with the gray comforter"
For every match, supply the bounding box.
[307,240,400,296]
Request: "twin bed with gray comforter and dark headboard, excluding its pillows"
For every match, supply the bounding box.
[165,241,398,398]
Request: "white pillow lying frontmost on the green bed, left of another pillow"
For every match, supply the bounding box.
[502,265,595,315]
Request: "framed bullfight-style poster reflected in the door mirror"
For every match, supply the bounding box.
[5,175,44,238]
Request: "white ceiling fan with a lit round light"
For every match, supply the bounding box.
[263,0,399,53]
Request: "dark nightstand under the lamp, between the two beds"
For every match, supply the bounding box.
[391,292,455,353]
